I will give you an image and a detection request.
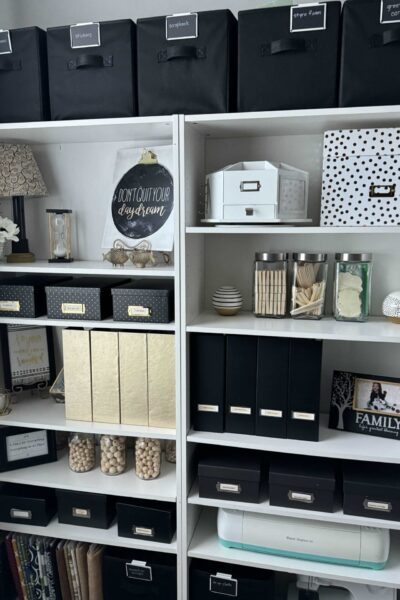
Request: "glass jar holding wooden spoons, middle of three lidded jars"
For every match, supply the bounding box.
[290,252,328,319]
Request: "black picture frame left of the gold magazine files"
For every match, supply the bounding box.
[0,325,56,392]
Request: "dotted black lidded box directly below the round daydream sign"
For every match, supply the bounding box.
[111,279,174,323]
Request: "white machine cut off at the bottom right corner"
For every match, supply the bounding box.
[288,575,396,600]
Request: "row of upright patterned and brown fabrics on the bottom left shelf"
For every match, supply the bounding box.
[0,533,103,600]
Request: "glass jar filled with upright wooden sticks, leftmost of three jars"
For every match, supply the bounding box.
[253,252,288,318]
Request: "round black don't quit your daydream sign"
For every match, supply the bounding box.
[111,163,174,239]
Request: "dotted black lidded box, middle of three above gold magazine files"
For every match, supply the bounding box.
[46,277,129,321]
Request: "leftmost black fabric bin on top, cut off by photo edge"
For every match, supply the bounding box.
[0,27,50,123]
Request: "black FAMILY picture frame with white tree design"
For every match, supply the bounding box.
[329,371,400,439]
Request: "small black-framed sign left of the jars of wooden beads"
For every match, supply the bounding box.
[0,425,57,473]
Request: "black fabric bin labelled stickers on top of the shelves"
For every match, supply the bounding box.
[47,19,137,120]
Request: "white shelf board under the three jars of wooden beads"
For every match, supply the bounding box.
[0,450,176,502]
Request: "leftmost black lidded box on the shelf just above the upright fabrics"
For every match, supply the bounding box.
[0,483,57,527]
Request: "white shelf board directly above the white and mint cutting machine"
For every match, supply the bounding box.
[188,482,400,530]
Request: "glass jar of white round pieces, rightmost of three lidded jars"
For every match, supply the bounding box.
[333,252,372,322]
